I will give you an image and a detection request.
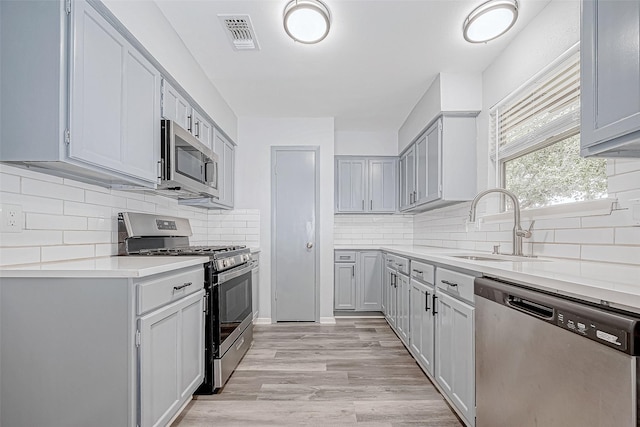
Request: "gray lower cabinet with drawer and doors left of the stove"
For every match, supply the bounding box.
[0,265,204,427]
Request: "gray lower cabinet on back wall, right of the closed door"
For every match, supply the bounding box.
[334,251,383,311]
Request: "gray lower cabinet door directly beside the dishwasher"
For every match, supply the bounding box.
[435,292,475,421]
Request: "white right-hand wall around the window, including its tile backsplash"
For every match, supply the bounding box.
[414,0,640,264]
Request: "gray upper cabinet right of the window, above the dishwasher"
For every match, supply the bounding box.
[580,0,640,157]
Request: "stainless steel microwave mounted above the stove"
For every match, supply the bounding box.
[158,120,220,199]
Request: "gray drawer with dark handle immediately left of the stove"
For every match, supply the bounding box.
[136,266,204,314]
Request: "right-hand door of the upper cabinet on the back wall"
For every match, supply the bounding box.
[366,159,397,212]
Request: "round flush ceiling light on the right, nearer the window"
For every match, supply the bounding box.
[462,0,518,43]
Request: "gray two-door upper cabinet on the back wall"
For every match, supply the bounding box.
[335,156,398,213]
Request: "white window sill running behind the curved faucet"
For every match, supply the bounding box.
[479,198,617,224]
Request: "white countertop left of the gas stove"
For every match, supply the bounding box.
[0,256,209,278]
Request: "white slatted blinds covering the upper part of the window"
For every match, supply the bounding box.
[491,49,580,161]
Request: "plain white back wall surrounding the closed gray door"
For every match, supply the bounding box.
[236,117,334,321]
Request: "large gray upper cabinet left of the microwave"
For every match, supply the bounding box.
[0,1,160,187]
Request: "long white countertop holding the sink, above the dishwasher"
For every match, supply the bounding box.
[334,245,640,313]
